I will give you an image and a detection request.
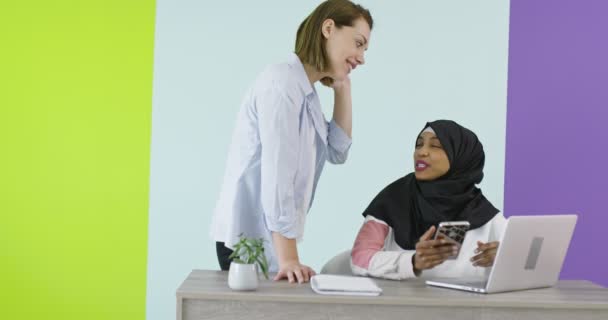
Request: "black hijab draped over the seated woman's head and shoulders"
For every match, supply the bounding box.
[363,120,499,250]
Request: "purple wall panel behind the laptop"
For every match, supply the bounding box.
[505,0,608,286]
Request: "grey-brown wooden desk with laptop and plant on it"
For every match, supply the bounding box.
[177,270,608,320]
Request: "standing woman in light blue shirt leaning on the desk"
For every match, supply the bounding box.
[211,0,373,283]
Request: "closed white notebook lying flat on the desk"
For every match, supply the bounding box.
[310,274,382,296]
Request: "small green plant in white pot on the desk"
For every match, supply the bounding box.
[228,234,268,290]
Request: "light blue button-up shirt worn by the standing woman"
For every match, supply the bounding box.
[211,54,351,271]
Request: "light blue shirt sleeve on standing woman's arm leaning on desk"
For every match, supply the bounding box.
[256,89,304,239]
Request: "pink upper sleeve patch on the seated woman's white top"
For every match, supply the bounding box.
[351,220,388,269]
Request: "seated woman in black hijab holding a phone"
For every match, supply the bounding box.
[351,120,506,280]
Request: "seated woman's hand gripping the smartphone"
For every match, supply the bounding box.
[412,226,458,274]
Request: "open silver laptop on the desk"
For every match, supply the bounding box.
[426,215,577,293]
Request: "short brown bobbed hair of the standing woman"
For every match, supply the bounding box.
[295,0,374,71]
